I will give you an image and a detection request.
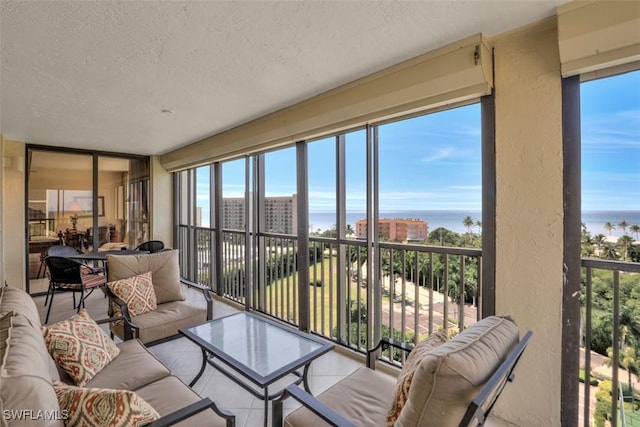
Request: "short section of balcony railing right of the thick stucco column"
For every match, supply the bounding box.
[580,258,640,427]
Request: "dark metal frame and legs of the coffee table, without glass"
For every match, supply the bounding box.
[179,311,334,426]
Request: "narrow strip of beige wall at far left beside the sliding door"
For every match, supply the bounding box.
[2,139,26,289]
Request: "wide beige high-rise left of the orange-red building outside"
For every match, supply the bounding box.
[222,194,298,234]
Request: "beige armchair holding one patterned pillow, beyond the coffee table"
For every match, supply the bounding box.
[105,249,213,344]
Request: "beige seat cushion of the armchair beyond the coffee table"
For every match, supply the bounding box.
[110,301,207,344]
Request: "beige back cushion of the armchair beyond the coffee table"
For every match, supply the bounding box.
[107,249,184,304]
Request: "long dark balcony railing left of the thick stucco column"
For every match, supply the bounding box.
[179,227,482,363]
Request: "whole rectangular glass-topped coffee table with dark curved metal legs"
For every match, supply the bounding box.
[180,312,334,426]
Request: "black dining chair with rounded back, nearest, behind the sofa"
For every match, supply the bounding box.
[44,256,107,323]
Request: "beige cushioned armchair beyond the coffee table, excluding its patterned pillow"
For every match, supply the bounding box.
[103,249,213,345]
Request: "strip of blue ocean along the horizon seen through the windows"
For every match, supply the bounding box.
[309,210,640,239]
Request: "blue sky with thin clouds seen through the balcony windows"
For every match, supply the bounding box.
[198,71,640,224]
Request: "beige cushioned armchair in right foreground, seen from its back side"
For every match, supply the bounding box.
[272,316,531,427]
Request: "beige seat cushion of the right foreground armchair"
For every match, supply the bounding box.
[284,367,396,427]
